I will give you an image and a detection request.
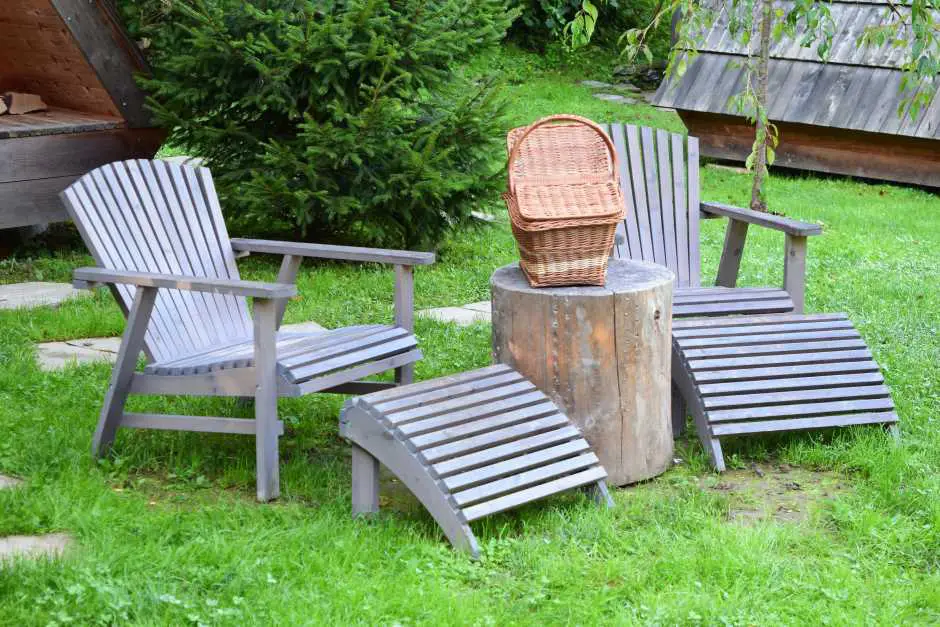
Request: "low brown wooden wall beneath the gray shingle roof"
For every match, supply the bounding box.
[678,110,940,188]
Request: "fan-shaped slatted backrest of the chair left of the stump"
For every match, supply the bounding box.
[62,160,251,361]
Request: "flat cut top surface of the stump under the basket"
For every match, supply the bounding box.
[490,259,676,297]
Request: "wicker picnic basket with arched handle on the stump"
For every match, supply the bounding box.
[503,115,624,287]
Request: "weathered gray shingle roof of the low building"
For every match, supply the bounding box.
[655,0,940,139]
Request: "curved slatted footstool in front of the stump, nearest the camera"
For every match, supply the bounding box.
[340,366,613,557]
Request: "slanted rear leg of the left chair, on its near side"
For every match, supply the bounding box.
[91,287,157,457]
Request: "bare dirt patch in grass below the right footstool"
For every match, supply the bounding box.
[701,464,851,525]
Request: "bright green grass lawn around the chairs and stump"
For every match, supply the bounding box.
[0,46,940,626]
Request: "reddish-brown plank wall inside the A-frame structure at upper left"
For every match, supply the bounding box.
[0,0,121,117]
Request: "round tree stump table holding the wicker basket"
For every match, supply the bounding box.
[490,260,675,485]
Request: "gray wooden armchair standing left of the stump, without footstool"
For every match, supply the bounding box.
[62,160,434,501]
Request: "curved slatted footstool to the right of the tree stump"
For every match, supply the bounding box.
[673,314,898,470]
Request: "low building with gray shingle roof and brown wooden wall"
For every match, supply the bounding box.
[654,0,940,187]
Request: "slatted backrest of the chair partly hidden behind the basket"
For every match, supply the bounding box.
[605,124,701,287]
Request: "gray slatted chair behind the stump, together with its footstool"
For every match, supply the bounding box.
[607,124,897,470]
